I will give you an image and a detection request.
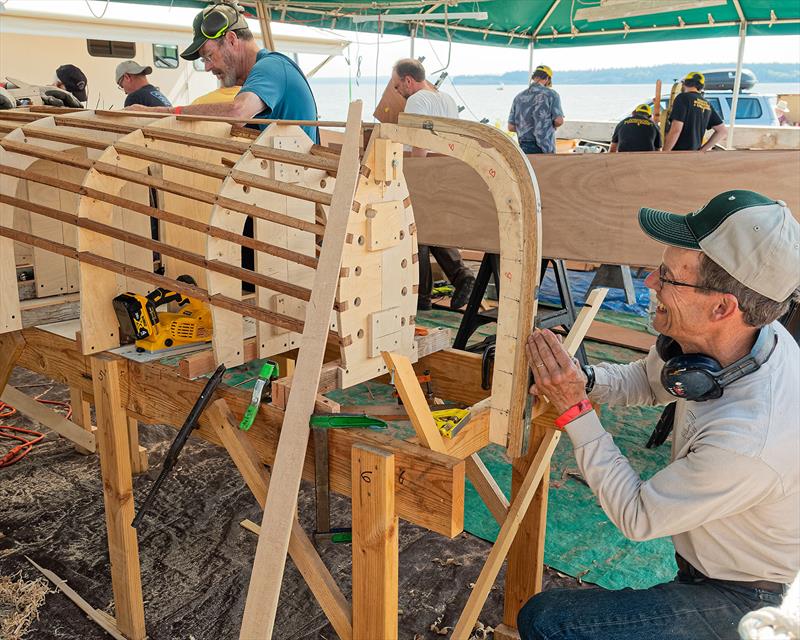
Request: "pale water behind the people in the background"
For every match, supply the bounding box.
[311,79,800,127]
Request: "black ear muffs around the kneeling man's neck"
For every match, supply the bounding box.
[656,325,778,402]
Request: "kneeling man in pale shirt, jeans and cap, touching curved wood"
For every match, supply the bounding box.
[518,191,800,640]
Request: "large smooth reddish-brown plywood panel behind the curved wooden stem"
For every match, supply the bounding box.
[405,150,800,266]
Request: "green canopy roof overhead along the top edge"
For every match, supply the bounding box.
[114,0,800,49]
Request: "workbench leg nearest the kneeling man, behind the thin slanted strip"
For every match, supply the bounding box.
[495,425,550,640]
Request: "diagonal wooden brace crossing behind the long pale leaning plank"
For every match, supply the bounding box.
[207,400,353,640]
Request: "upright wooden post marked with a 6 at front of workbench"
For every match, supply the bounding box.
[351,445,399,640]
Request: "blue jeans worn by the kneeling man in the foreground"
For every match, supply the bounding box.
[517,578,782,640]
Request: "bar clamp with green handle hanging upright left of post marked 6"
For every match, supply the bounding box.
[309,413,387,543]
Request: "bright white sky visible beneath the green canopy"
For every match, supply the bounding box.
[6,0,800,78]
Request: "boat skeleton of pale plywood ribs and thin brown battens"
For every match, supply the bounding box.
[0,111,417,387]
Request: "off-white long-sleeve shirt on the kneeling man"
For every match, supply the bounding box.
[566,322,800,583]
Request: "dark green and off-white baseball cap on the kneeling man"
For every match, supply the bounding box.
[639,190,800,302]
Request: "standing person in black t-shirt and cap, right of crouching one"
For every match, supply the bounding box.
[664,71,728,151]
